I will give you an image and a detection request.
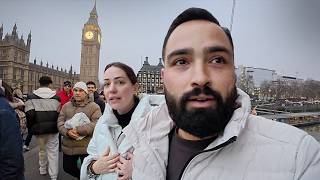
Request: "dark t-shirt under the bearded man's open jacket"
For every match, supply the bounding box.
[167,130,216,180]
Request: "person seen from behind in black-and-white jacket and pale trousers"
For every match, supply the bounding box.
[25,76,60,179]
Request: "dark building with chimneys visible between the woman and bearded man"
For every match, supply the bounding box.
[137,57,163,94]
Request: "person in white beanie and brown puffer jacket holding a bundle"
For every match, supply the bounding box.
[58,81,101,178]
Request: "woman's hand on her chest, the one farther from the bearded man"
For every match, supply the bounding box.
[91,147,119,174]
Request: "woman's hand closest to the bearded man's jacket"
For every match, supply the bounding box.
[116,152,133,180]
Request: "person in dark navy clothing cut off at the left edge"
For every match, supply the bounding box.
[0,79,24,180]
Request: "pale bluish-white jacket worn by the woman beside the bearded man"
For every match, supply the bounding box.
[80,94,164,180]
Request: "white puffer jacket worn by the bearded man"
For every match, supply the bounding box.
[124,89,320,180]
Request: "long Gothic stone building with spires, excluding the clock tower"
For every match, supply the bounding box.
[0,24,79,94]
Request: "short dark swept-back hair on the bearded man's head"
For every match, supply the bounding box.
[162,7,233,61]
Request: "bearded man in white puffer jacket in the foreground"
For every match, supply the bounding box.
[124,8,320,180]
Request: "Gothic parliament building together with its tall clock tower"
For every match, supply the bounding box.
[0,4,101,94]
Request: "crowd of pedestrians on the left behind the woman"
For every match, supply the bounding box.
[0,76,105,180]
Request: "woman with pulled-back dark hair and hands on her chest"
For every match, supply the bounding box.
[81,62,164,180]
